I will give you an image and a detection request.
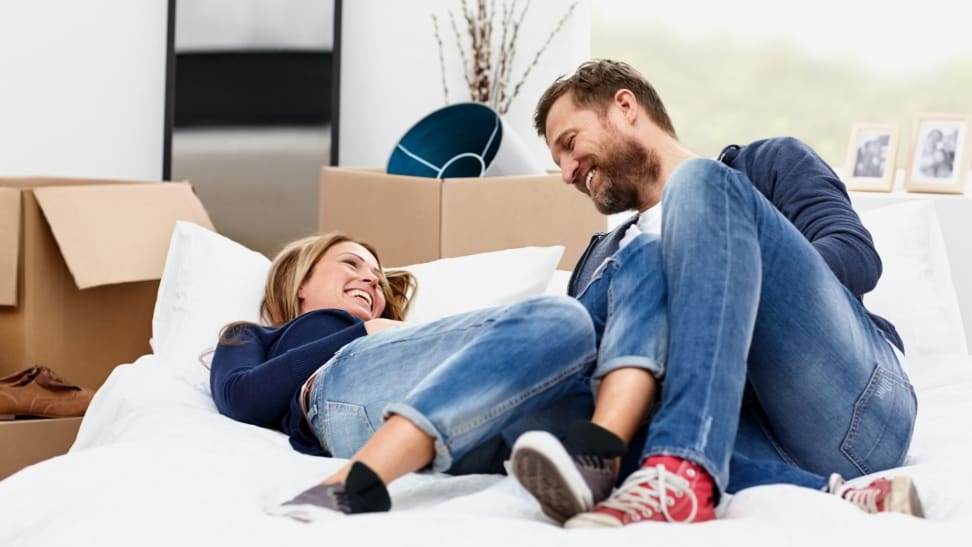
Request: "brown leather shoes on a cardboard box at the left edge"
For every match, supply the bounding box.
[0,367,94,418]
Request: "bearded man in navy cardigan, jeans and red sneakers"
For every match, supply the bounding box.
[512,61,921,527]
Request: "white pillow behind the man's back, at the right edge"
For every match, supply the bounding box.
[860,200,968,356]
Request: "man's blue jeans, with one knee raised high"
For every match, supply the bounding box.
[641,159,917,493]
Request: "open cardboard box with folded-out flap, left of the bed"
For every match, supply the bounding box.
[0,178,213,389]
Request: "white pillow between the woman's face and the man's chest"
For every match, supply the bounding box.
[394,245,564,323]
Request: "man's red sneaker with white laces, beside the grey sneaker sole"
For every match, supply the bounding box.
[564,456,715,528]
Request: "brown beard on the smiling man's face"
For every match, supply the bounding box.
[591,137,661,215]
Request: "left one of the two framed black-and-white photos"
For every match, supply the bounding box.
[845,123,898,192]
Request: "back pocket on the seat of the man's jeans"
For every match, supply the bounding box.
[840,365,916,474]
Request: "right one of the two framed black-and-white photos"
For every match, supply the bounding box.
[905,114,972,194]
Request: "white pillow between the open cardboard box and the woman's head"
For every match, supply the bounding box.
[151,221,270,367]
